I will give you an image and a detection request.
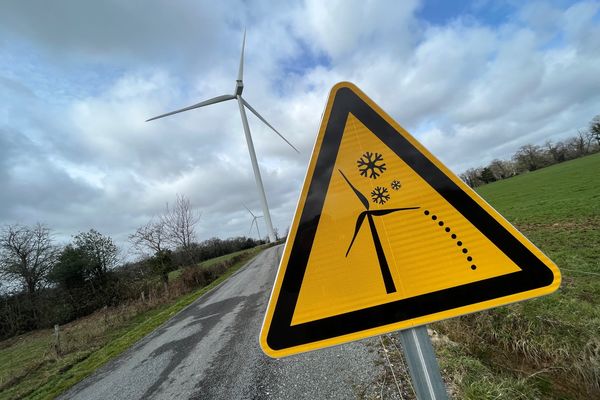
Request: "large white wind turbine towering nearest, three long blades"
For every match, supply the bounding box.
[146,31,300,242]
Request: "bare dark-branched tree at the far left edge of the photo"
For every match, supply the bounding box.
[0,223,58,298]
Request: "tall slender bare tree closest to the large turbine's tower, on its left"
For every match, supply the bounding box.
[161,195,200,261]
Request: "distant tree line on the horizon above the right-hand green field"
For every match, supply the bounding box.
[459,115,600,187]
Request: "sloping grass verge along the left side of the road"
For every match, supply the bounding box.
[0,246,265,400]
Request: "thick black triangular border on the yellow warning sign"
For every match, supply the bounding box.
[266,87,554,350]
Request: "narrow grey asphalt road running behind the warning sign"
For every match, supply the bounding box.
[61,246,395,400]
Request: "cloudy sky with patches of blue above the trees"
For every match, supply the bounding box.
[0,0,600,250]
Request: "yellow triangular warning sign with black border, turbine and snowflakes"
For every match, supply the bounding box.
[260,83,560,357]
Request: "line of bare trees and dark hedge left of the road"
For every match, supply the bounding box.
[0,195,264,340]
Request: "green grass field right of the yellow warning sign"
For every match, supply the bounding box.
[433,154,600,399]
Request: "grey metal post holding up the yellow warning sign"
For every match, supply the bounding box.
[400,325,448,400]
